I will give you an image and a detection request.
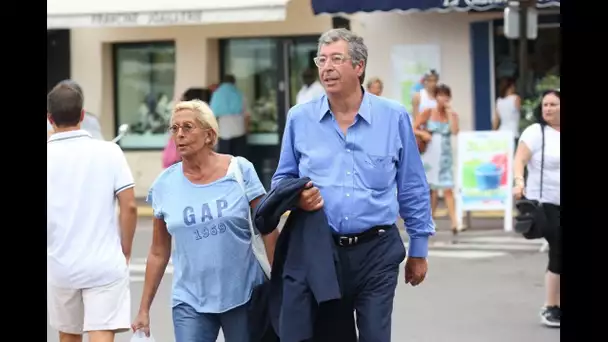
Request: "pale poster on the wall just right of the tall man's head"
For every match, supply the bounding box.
[390,45,441,113]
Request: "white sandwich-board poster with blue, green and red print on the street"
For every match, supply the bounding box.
[457,131,514,231]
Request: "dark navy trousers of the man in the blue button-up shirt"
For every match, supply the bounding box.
[336,226,406,342]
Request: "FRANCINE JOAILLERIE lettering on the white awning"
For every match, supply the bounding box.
[91,11,203,26]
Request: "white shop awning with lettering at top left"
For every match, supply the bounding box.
[46,0,289,29]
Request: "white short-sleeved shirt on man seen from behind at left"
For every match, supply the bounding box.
[46,130,134,289]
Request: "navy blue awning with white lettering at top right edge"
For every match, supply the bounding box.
[312,0,560,14]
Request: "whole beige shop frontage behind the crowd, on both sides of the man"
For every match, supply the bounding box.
[47,0,559,197]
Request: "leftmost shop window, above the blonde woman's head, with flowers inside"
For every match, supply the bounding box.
[114,43,175,149]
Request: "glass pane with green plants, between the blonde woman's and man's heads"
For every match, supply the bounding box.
[222,38,279,145]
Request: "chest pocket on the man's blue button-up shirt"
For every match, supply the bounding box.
[358,153,397,190]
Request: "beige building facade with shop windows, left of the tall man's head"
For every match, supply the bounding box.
[47,0,332,196]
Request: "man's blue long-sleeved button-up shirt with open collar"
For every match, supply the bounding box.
[272,92,435,257]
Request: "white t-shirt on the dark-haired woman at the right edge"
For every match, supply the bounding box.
[519,124,560,205]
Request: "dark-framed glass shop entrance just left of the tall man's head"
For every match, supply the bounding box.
[220,36,318,189]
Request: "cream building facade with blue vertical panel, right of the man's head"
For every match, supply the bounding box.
[350,7,561,130]
